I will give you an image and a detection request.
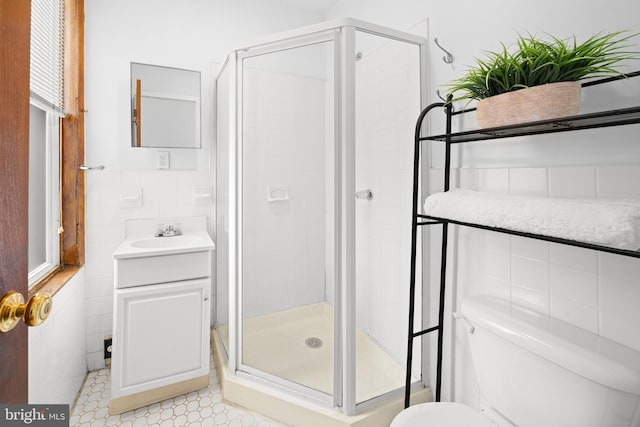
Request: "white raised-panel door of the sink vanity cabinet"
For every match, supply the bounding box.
[112,279,211,398]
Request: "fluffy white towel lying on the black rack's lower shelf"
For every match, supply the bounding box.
[424,190,640,251]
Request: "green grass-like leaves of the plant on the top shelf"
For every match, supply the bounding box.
[447,31,640,101]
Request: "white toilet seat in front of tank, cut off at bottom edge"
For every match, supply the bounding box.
[389,402,496,427]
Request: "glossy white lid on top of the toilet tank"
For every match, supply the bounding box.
[460,295,640,395]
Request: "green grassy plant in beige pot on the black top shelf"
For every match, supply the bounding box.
[447,31,638,128]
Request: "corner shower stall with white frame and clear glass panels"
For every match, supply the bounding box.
[215,19,426,415]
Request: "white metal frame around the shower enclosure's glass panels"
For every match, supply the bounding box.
[223,18,429,415]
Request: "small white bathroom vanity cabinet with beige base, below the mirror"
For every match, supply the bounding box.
[110,219,213,414]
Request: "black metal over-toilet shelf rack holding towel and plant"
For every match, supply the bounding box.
[404,71,640,408]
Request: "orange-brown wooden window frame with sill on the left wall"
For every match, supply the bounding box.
[29,0,86,296]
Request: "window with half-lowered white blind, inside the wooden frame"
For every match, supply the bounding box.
[28,0,65,286]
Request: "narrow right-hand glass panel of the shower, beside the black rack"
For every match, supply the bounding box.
[355,31,421,403]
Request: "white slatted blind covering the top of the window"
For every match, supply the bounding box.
[30,0,64,115]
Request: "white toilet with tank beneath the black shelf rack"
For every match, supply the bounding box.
[391,295,640,427]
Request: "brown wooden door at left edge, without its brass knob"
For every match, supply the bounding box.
[0,0,31,403]
